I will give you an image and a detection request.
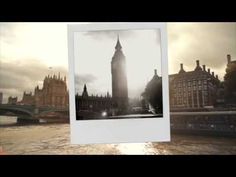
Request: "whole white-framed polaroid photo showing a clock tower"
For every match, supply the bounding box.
[68,23,170,144]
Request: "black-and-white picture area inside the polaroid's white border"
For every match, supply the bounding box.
[74,29,163,120]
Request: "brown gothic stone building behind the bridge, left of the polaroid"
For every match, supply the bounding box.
[20,73,69,108]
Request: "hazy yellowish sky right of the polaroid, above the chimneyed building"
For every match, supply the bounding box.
[168,23,236,78]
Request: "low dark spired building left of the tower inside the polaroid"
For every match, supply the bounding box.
[75,84,113,117]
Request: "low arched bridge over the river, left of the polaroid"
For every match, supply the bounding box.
[0,104,69,122]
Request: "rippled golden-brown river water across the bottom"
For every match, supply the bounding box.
[0,118,236,154]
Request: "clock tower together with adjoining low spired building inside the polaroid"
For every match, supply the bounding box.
[76,36,128,114]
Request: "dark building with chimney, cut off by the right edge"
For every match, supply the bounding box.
[224,55,236,105]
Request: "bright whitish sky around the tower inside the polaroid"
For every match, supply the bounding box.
[74,30,161,98]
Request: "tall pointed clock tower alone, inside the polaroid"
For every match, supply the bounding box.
[111,36,128,114]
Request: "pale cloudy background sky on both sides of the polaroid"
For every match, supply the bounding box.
[0,23,236,102]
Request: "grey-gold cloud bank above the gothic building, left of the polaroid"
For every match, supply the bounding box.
[0,59,67,102]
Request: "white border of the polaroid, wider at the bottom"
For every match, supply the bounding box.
[68,22,170,144]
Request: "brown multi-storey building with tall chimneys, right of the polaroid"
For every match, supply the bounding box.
[169,60,220,108]
